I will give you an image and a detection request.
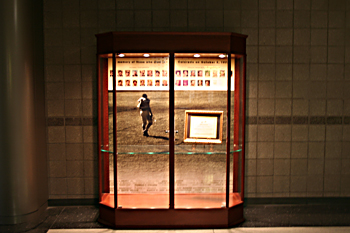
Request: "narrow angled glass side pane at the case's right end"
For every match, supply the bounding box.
[229,55,243,207]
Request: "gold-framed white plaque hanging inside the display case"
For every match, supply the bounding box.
[184,110,224,143]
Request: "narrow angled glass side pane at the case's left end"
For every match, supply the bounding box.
[98,54,115,208]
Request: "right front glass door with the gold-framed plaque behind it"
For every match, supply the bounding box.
[174,53,227,208]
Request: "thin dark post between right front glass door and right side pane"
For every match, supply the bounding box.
[226,53,232,208]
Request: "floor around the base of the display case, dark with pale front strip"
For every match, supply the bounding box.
[0,203,350,233]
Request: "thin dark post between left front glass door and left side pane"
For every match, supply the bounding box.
[112,53,118,208]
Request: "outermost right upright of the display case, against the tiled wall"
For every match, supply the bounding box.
[241,55,247,201]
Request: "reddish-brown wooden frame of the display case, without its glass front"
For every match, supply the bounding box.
[96,32,247,229]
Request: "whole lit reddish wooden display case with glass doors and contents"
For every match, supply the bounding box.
[96,32,247,228]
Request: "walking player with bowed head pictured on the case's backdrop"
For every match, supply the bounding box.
[137,94,153,137]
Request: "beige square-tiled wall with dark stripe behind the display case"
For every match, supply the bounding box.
[44,0,350,199]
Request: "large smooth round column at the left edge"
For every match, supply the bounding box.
[0,0,46,225]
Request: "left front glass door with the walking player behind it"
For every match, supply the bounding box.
[109,53,169,209]
